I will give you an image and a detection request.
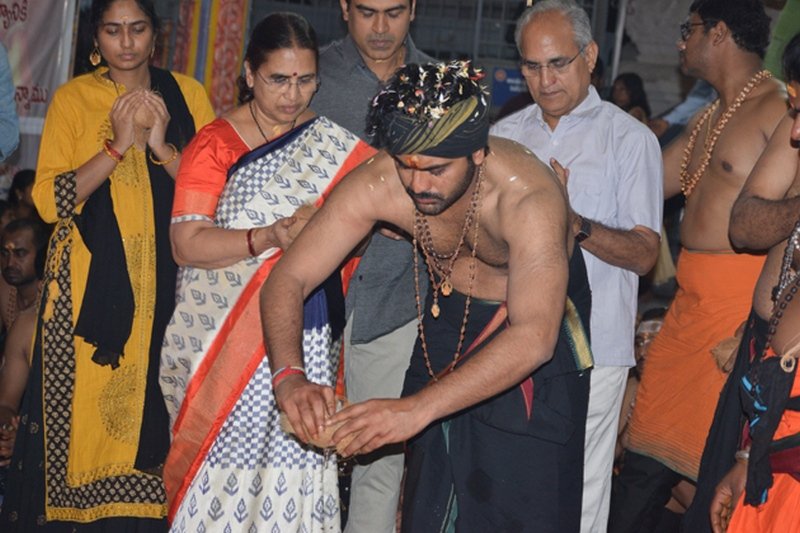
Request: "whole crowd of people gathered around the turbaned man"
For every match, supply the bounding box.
[0,0,800,533]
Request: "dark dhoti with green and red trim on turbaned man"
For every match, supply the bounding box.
[402,249,591,533]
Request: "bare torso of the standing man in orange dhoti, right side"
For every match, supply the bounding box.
[664,80,786,252]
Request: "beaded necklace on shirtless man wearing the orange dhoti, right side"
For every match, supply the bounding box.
[680,70,772,198]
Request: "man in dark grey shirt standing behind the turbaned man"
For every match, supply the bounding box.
[311,0,433,533]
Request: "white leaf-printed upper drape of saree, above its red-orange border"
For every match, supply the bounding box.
[160,117,358,424]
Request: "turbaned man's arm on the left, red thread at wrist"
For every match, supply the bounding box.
[261,158,396,441]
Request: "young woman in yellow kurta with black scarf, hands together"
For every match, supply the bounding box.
[0,0,214,533]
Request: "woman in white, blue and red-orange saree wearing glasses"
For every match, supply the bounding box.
[161,13,373,531]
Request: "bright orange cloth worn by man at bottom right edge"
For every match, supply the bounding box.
[728,373,800,533]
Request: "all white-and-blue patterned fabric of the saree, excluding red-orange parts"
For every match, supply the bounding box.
[160,118,358,533]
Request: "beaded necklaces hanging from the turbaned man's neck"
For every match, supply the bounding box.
[412,164,485,381]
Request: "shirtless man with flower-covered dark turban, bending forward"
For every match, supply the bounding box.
[261,61,592,532]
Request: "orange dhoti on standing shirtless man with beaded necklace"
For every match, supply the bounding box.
[628,250,764,480]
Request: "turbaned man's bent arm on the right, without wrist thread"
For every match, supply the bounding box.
[329,165,579,455]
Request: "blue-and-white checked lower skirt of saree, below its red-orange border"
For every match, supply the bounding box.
[172,328,340,533]
